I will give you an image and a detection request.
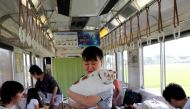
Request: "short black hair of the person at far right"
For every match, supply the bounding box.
[163,83,186,102]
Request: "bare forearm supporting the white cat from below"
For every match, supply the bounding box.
[67,90,101,107]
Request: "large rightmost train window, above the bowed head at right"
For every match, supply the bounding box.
[165,37,190,95]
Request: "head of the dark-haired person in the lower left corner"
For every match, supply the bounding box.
[0,81,24,109]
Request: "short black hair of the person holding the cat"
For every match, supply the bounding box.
[82,46,103,61]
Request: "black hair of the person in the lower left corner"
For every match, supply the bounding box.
[0,81,24,105]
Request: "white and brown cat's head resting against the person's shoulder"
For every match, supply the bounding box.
[98,69,116,84]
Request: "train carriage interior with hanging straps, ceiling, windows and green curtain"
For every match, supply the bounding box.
[0,0,190,109]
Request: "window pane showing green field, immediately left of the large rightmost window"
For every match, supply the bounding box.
[143,44,160,91]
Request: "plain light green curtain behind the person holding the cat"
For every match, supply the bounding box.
[52,58,85,97]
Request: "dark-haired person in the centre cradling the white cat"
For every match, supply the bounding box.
[67,46,113,109]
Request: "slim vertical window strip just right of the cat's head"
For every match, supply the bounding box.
[123,50,128,83]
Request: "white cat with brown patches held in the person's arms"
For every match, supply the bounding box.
[69,69,116,102]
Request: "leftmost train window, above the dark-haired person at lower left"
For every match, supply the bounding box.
[0,48,13,86]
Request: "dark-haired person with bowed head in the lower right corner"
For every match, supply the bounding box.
[163,83,190,109]
